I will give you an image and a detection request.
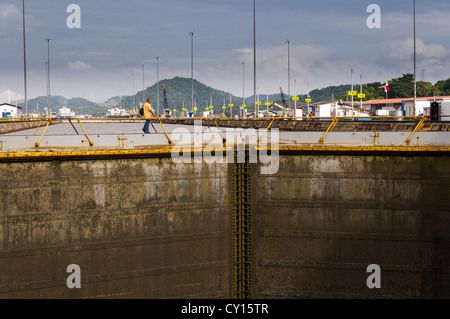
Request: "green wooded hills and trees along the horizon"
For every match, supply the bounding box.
[20,74,450,116]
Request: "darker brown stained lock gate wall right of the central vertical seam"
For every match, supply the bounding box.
[252,155,450,298]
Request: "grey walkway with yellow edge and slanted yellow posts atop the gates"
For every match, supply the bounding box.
[0,117,450,159]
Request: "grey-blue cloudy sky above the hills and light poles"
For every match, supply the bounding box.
[0,0,450,102]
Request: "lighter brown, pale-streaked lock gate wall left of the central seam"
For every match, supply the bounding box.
[0,158,230,298]
